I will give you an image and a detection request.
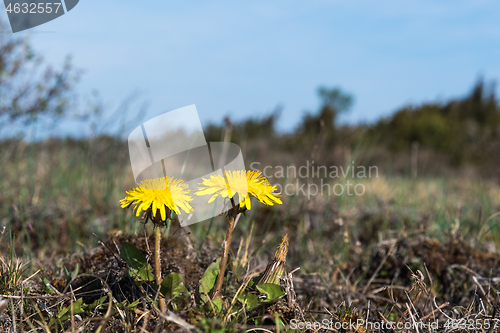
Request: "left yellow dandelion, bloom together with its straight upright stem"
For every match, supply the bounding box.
[120,177,193,312]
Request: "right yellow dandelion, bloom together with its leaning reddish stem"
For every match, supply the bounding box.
[195,170,282,299]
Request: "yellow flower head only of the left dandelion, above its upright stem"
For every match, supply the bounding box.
[120,177,193,221]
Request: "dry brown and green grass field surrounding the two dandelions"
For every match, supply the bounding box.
[0,137,500,332]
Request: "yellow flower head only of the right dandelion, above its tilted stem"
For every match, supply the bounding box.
[195,170,282,209]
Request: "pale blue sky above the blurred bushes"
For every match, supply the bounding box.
[0,0,500,136]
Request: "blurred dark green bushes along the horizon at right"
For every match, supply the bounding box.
[206,79,500,181]
